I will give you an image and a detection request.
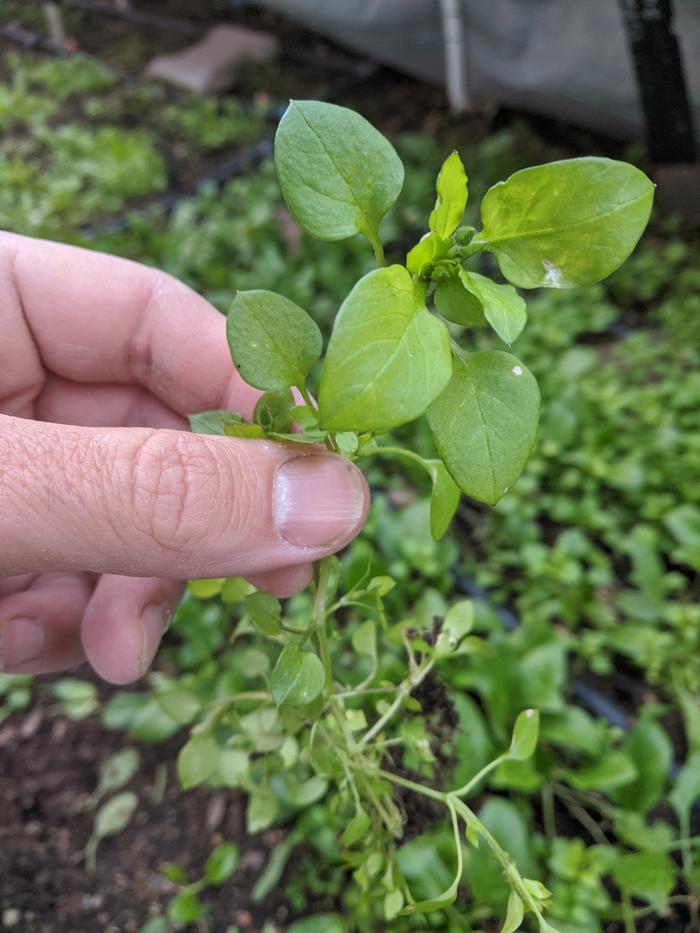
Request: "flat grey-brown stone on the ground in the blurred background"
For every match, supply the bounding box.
[146,25,278,93]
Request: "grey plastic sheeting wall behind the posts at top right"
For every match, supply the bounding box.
[253,0,700,137]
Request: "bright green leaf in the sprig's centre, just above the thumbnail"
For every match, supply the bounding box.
[319,266,452,431]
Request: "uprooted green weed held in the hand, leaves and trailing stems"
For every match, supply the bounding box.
[185,101,653,933]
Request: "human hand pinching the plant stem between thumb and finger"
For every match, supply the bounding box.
[0,234,368,683]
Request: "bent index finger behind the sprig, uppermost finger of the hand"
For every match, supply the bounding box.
[0,234,260,415]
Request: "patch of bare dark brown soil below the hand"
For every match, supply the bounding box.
[0,684,288,933]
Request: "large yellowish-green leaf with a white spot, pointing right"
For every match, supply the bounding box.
[480,157,654,288]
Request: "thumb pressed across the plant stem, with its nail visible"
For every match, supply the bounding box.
[0,416,369,579]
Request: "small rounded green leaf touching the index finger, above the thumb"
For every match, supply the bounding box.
[226,291,323,391]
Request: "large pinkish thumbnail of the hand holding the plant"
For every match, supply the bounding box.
[275,454,367,547]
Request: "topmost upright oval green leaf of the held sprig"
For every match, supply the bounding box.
[275,100,404,253]
